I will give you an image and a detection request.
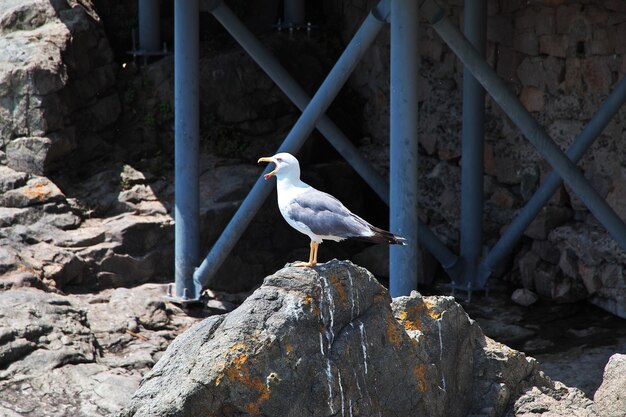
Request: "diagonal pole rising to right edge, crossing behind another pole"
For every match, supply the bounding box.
[479,77,626,285]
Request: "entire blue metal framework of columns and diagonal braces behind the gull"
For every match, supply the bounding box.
[168,0,626,298]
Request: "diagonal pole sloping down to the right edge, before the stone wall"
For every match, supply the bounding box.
[422,0,626,270]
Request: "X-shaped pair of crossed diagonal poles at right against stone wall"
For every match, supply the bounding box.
[421,0,626,294]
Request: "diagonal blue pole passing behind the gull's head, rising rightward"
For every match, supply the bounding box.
[194,0,389,287]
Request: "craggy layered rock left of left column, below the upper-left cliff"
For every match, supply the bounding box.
[0,161,173,290]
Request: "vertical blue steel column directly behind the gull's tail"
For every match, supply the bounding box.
[389,0,419,297]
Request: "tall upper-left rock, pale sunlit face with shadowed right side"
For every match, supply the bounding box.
[0,0,120,175]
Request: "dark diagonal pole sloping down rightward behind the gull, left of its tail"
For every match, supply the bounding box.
[209,1,389,205]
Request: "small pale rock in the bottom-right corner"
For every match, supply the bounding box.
[593,354,626,417]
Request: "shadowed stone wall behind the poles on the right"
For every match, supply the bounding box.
[326,0,626,316]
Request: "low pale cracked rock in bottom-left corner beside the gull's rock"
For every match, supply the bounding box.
[0,285,196,417]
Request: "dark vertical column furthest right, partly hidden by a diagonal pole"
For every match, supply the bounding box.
[452,0,487,292]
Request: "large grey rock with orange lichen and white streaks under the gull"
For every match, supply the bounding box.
[119,261,595,417]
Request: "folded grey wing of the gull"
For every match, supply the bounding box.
[288,189,372,238]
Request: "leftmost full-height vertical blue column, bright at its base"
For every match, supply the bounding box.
[174,0,200,299]
